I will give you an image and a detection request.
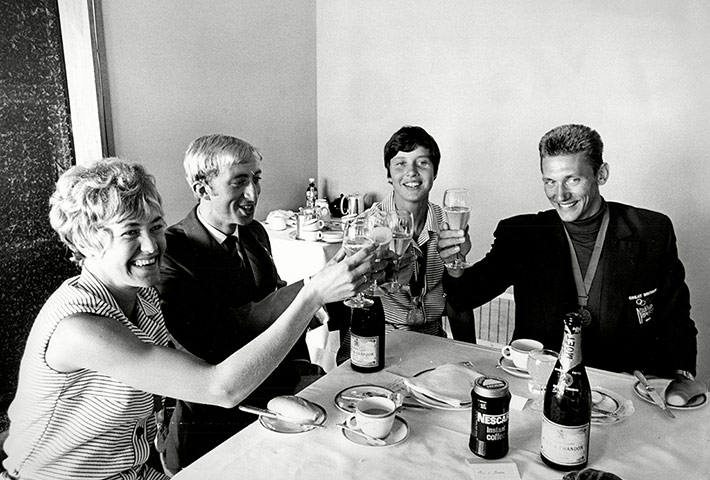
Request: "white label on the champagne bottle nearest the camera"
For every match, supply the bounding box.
[540,416,589,467]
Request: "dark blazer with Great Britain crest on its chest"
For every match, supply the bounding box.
[444,202,697,376]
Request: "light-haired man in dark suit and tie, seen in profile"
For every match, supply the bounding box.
[158,135,372,472]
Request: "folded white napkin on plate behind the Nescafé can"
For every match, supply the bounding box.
[404,362,481,408]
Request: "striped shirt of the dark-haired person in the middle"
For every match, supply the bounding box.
[370,192,446,336]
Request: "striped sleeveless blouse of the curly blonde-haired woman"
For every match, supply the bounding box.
[0,269,168,480]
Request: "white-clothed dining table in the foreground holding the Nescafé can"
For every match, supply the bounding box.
[175,330,710,480]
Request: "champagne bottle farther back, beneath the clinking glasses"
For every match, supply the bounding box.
[350,299,385,373]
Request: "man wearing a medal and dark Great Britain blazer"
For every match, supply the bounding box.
[439,125,697,379]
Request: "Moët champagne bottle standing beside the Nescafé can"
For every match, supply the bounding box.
[540,312,592,470]
